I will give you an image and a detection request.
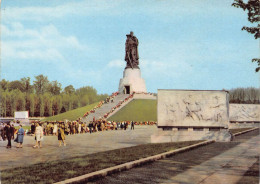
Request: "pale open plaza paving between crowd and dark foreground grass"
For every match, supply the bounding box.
[0,125,157,170]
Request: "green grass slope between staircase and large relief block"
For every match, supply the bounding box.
[108,99,157,121]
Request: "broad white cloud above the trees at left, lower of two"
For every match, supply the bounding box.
[2,23,87,60]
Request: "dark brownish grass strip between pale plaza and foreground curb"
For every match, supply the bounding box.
[1,141,201,184]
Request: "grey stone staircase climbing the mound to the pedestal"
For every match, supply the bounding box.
[82,94,131,122]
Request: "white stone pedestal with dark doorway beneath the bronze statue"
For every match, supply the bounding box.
[118,68,147,94]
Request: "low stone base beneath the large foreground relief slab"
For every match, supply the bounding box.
[151,128,231,143]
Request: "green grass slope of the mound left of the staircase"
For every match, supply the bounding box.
[41,102,99,121]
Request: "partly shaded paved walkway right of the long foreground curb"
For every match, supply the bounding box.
[93,130,260,184]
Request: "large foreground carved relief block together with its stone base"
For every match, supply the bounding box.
[151,90,231,143]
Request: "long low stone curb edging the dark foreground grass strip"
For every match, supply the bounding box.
[56,140,215,184]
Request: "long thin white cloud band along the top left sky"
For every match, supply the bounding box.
[2,0,120,22]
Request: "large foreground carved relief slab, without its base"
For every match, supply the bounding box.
[157,90,229,128]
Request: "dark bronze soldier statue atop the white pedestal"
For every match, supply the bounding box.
[125,31,139,69]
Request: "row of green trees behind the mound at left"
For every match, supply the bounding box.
[0,75,108,117]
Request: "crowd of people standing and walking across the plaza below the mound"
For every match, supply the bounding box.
[0,119,156,148]
